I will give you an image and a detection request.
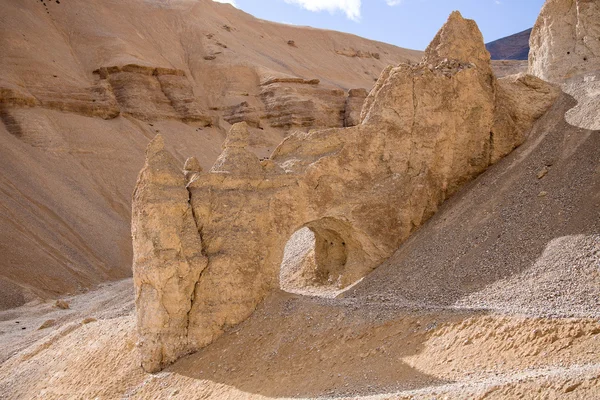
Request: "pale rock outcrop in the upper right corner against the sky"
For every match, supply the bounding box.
[529,0,600,82]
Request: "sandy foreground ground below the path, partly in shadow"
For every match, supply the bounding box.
[0,280,600,399]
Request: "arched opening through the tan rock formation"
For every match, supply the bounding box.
[279,224,358,297]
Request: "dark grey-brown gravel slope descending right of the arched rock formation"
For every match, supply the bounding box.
[344,94,600,316]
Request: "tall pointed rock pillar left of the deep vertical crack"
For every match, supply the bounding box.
[132,136,207,371]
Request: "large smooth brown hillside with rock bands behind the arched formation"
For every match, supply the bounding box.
[0,0,420,309]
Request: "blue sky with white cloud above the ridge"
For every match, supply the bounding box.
[214,0,544,50]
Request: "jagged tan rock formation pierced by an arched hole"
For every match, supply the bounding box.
[133,12,557,371]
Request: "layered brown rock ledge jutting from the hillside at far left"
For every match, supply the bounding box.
[0,64,214,126]
